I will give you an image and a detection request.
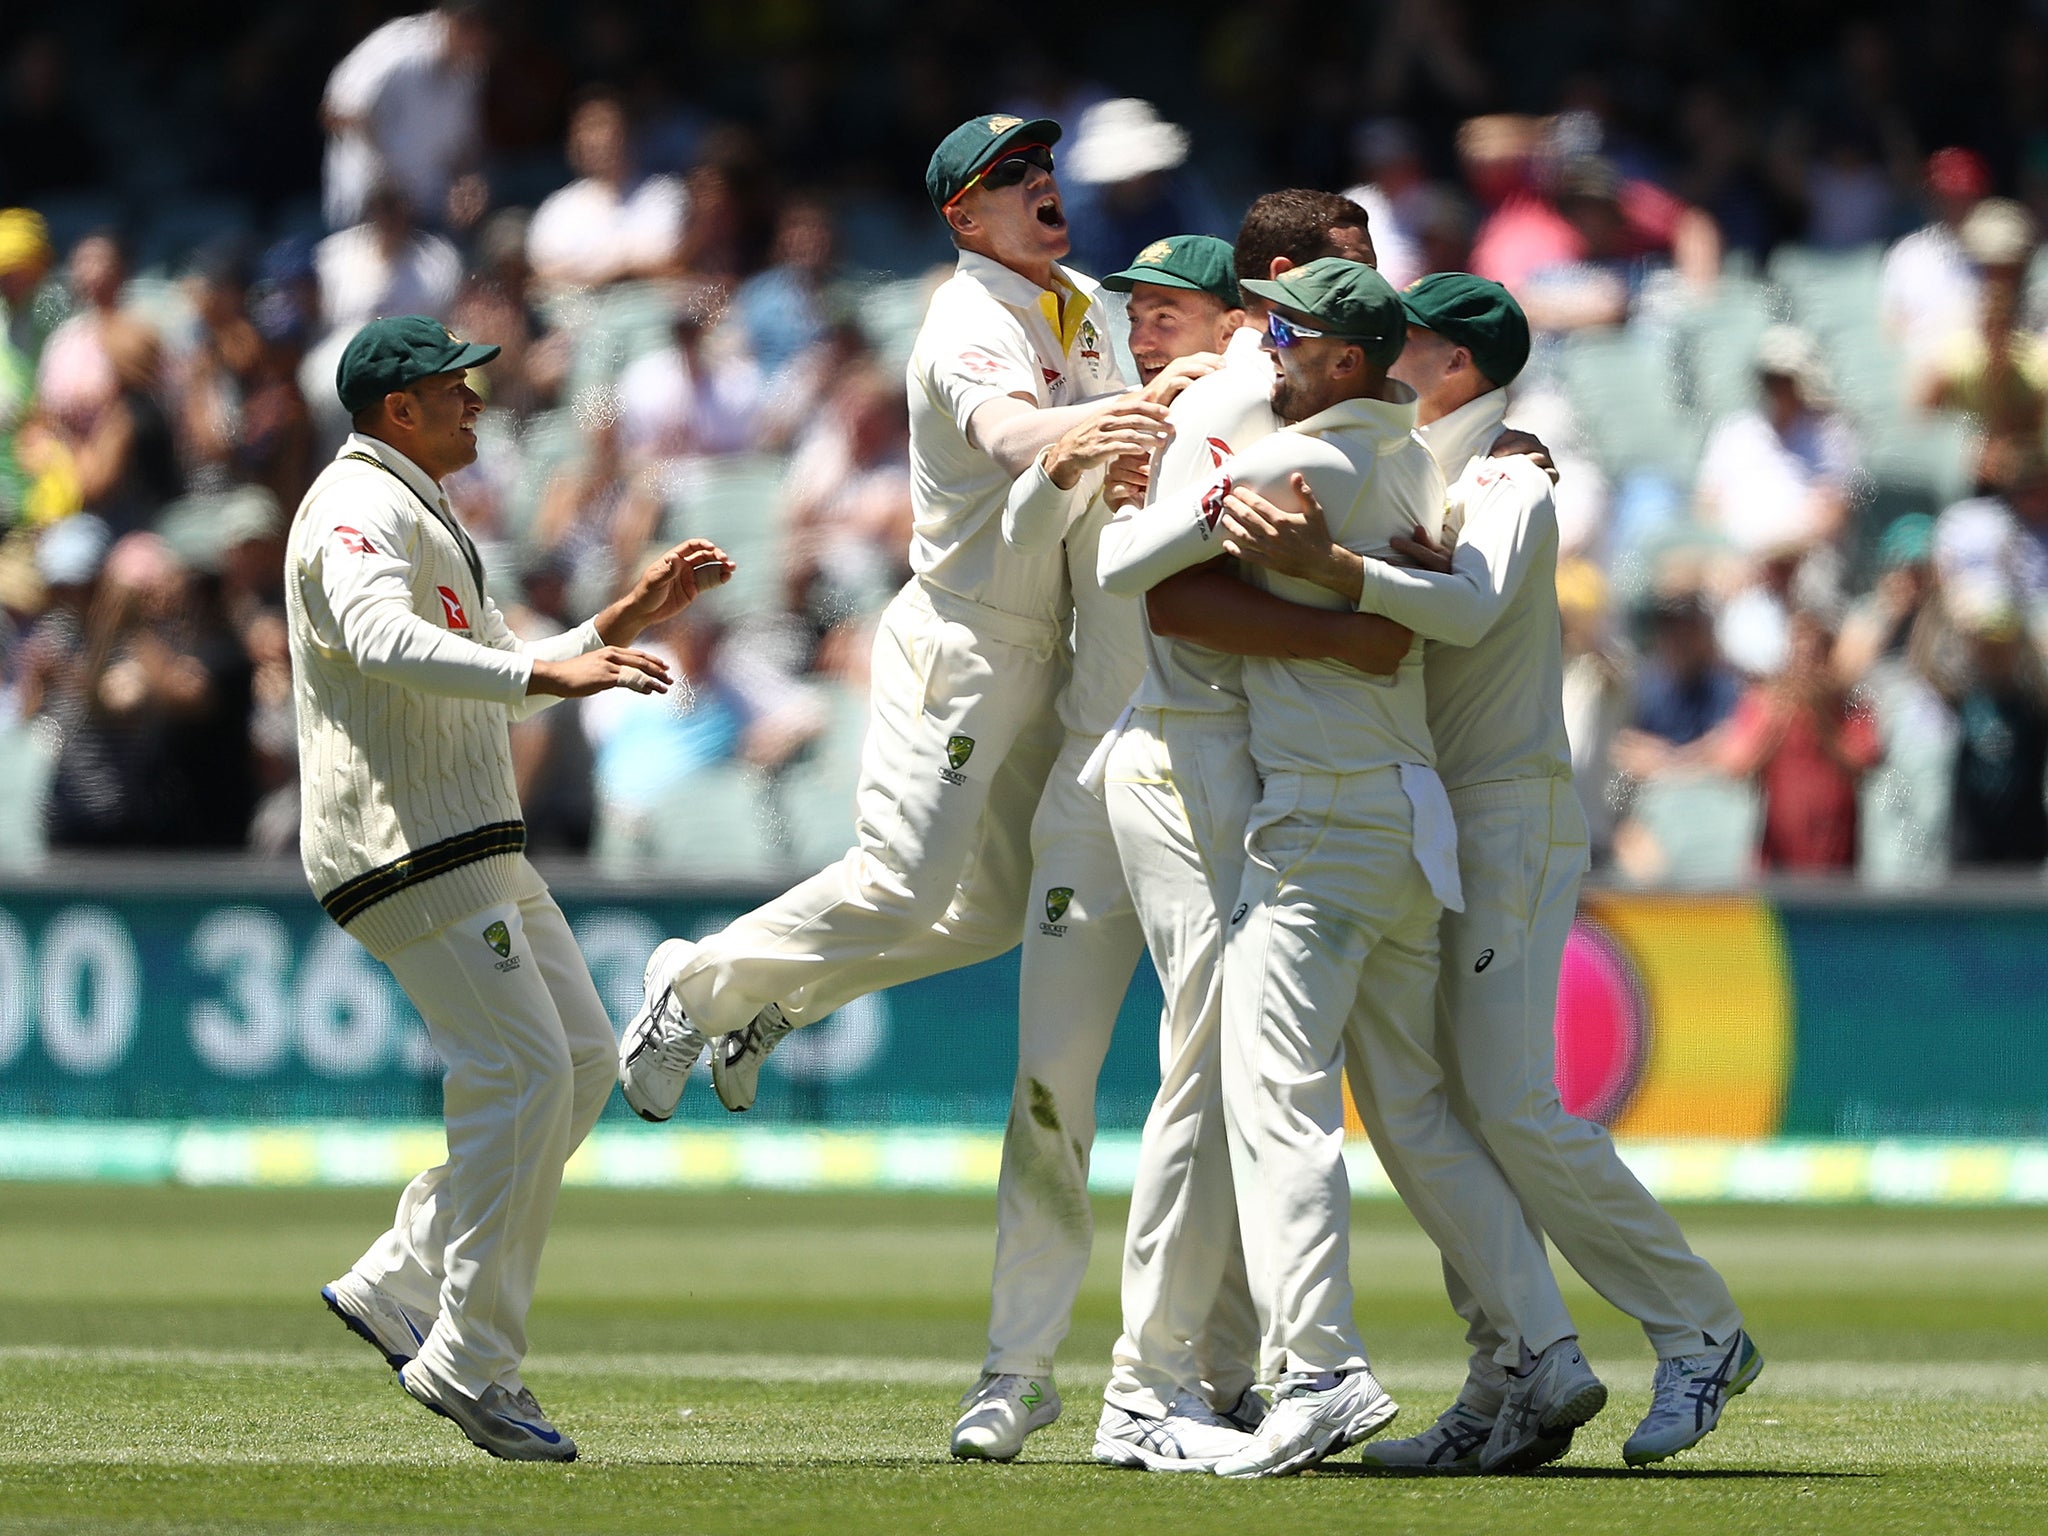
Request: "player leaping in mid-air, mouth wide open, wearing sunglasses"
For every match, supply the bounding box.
[618,115,1178,1120]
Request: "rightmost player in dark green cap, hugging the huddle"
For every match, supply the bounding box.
[1225,272,1761,1470]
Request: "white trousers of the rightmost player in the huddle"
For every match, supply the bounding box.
[1436,778,1743,1389]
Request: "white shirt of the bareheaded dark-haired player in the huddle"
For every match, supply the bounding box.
[1098,326,1280,715]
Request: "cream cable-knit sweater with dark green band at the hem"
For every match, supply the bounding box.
[285,432,602,958]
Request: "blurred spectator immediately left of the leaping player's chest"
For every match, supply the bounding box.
[782,371,911,633]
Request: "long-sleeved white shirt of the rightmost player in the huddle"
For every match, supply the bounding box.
[1358,389,1571,788]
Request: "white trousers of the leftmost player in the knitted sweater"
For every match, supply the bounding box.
[354,866,618,1397]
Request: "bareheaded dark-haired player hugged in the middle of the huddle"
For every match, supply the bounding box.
[1096,190,1441,1470]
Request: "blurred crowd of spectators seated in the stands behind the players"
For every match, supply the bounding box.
[0,0,2048,885]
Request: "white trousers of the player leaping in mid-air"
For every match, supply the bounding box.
[672,578,1067,1034]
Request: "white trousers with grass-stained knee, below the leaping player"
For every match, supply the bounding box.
[983,733,1145,1376]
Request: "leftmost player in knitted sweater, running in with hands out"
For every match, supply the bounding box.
[285,315,731,1460]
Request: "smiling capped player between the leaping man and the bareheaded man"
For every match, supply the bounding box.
[952,236,1243,1460]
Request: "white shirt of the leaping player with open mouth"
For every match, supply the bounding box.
[907,250,1124,623]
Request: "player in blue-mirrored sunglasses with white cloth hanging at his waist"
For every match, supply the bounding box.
[1112,260,1606,1477]
